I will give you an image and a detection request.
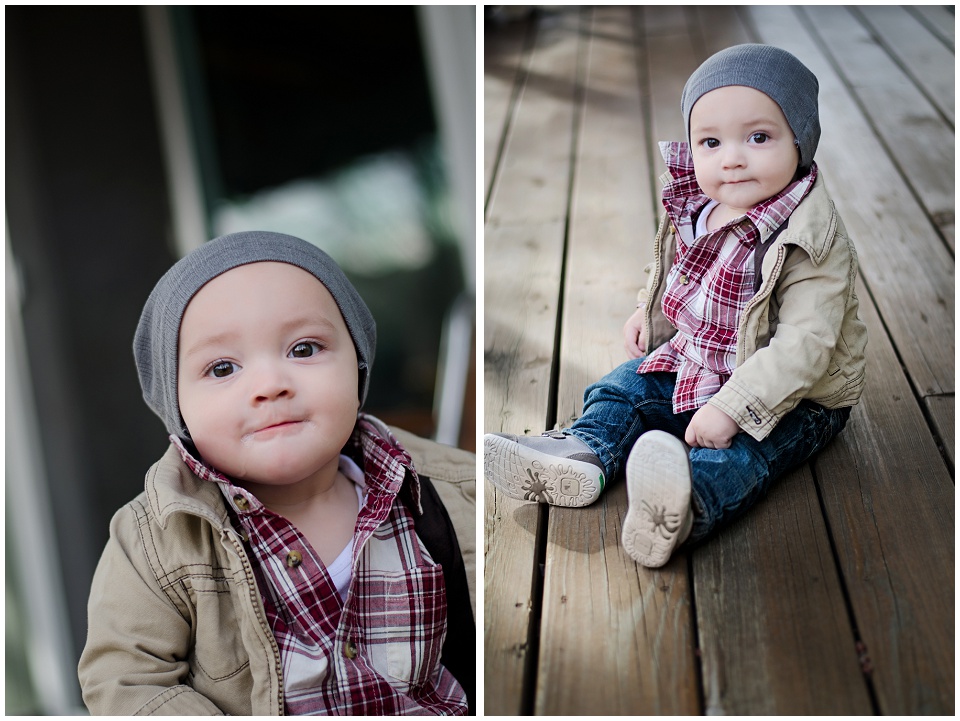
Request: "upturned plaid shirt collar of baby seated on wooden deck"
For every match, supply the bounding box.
[660,141,818,243]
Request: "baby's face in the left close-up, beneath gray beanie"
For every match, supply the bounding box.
[177,262,360,485]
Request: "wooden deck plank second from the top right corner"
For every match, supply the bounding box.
[857,5,956,125]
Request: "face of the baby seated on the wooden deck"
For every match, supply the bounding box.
[690,85,800,213]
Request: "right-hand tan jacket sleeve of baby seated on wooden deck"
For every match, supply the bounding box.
[709,234,857,440]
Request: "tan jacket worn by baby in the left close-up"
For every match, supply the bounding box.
[79,428,476,716]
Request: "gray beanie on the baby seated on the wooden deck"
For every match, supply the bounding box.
[680,44,820,169]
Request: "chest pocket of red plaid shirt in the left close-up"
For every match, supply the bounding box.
[364,566,447,687]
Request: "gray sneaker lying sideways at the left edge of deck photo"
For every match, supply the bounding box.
[483,431,606,507]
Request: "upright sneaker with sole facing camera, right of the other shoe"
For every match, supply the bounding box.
[621,431,693,568]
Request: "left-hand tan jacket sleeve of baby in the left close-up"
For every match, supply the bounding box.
[79,501,222,715]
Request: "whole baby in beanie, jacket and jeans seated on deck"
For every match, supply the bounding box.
[484,44,867,567]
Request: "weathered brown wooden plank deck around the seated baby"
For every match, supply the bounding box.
[483,6,955,715]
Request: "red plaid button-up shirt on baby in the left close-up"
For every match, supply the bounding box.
[171,414,467,716]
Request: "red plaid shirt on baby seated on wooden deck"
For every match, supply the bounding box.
[637,142,817,413]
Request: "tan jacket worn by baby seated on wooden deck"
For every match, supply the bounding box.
[639,175,867,440]
